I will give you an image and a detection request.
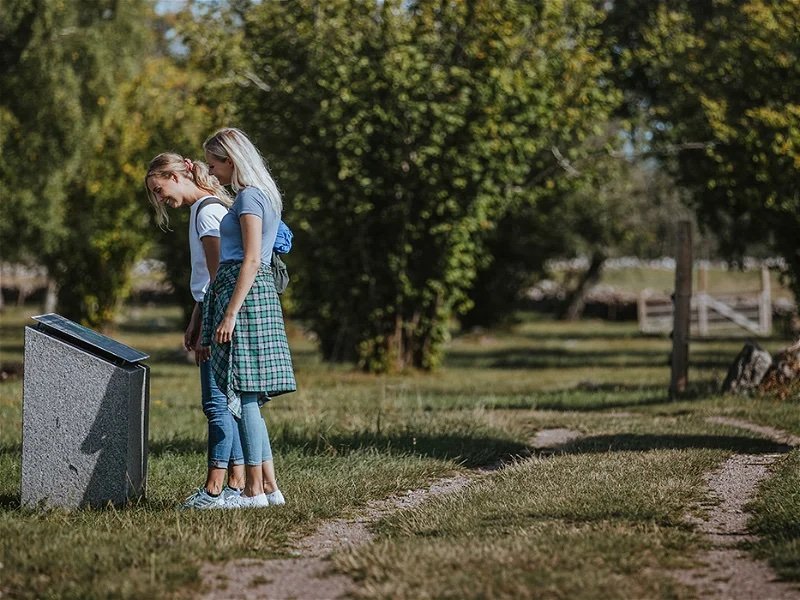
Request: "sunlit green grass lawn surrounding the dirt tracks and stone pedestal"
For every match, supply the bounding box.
[0,308,800,598]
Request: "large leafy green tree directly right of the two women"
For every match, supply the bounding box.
[189,0,616,371]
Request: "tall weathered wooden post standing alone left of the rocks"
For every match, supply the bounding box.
[669,221,692,398]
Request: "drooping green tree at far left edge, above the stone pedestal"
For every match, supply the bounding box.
[0,0,142,259]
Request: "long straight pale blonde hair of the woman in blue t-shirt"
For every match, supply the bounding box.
[203,127,283,215]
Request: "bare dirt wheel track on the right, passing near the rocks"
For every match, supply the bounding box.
[677,417,800,600]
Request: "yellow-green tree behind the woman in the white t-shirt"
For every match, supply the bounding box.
[51,57,222,327]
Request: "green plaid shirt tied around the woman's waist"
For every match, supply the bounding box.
[202,263,297,418]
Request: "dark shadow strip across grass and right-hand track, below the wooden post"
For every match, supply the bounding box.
[558,433,792,454]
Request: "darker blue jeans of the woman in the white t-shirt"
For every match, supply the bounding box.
[200,361,244,469]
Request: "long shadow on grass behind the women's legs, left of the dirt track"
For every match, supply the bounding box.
[149,431,530,468]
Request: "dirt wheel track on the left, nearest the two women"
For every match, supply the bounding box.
[197,429,581,600]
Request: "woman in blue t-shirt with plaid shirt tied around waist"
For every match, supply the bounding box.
[202,128,297,508]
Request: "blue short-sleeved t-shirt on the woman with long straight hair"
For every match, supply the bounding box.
[219,186,281,264]
